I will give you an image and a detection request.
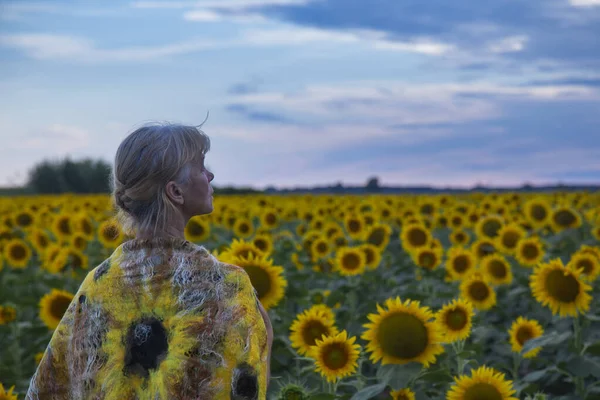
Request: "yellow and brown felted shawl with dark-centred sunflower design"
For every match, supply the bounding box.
[26,238,268,400]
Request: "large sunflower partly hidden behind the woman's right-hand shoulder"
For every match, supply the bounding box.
[229,254,287,310]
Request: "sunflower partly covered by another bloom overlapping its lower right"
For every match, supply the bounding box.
[290,308,338,356]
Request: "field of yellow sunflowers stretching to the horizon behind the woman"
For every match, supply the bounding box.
[0,192,600,400]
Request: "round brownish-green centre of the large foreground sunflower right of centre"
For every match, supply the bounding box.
[377,313,429,359]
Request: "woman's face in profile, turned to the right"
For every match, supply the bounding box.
[183,157,215,218]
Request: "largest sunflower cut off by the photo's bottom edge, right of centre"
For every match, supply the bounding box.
[446,365,519,400]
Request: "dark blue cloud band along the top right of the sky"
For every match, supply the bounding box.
[247,0,600,66]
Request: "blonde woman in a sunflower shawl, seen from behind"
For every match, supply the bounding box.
[26,124,273,400]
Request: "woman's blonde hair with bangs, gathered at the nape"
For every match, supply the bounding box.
[111,122,210,235]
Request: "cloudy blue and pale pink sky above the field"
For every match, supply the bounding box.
[0,0,600,189]
